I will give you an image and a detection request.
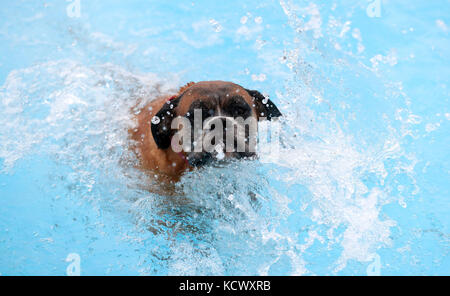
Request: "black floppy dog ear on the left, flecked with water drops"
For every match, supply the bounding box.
[152,96,181,149]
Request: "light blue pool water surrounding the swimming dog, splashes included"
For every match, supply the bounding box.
[0,0,450,275]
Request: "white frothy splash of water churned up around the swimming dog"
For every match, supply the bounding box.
[0,1,426,275]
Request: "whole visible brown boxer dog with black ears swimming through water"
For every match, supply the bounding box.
[130,81,281,183]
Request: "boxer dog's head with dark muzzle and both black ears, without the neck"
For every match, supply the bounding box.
[151,81,281,166]
